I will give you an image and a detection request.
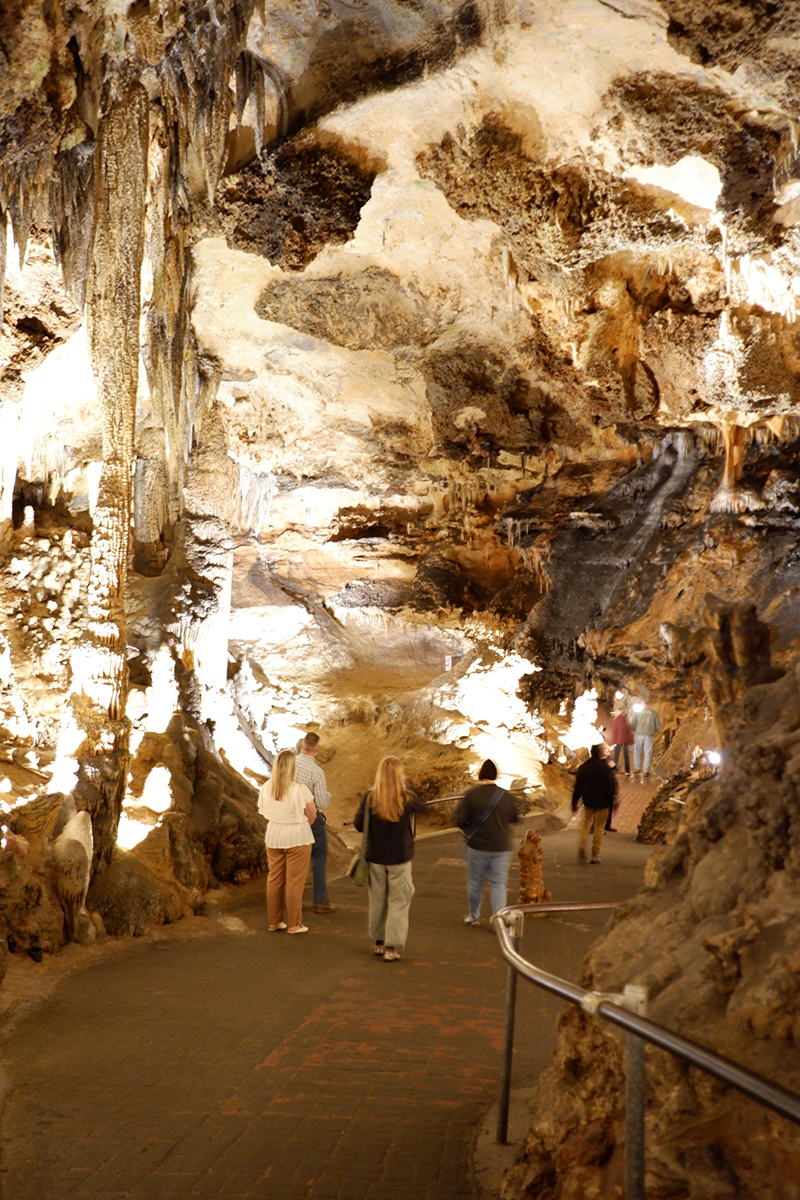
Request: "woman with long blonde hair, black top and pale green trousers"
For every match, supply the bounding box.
[353,757,425,962]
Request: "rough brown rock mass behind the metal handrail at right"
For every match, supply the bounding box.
[503,628,800,1198]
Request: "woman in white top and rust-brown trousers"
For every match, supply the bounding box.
[258,750,317,934]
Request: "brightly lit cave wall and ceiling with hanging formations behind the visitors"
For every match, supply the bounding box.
[0,0,800,1194]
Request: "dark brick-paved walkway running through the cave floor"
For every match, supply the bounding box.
[0,830,648,1200]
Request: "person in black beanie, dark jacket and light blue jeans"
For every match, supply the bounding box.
[453,758,519,925]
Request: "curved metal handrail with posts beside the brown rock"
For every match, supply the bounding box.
[492,900,800,1200]
